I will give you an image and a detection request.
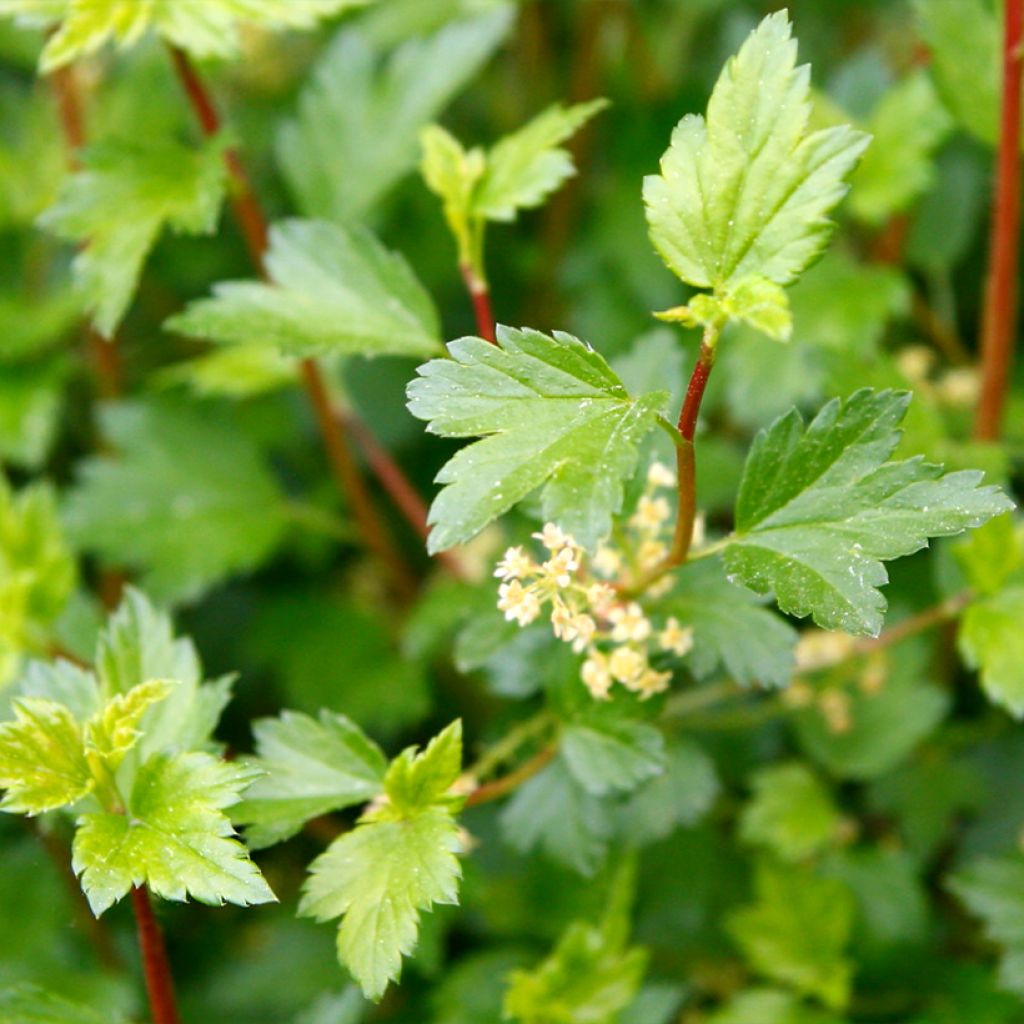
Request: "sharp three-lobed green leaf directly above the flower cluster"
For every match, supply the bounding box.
[409,328,667,552]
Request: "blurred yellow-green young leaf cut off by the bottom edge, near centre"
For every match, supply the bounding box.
[504,869,647,1024]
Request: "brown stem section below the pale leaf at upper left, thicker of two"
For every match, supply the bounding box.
[301,359,416,598]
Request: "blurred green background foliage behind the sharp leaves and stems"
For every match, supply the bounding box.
[0,0,1024,1024]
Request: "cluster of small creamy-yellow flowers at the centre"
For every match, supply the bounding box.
[495,463,693,699]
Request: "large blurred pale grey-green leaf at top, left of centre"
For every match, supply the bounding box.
[276,8,511,224]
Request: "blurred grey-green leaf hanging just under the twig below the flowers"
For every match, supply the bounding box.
[501,756,612,877]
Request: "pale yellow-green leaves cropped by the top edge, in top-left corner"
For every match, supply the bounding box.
[0,0,372,73]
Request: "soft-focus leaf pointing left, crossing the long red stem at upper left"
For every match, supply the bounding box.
[165,220,440,356]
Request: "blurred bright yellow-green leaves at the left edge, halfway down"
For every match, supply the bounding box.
[0,473,77,686]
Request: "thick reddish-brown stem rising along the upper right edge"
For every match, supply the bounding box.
[974,0,1024,440]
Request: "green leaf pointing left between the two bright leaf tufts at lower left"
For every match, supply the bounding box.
[231,711,387,849]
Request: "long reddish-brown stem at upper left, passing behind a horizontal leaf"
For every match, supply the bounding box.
[170,46,423,597]
